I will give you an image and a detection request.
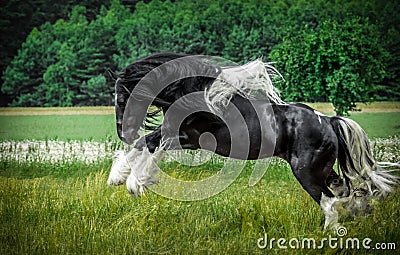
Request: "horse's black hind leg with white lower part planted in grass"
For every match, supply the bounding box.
[289,152,338,229]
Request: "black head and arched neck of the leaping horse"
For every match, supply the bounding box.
[109,53,221,144]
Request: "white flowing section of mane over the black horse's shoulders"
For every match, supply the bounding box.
[205,59,286,113]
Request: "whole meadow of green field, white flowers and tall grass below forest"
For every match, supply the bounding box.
[0,104,400,254]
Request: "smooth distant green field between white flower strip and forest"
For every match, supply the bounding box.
[0,102,400,141]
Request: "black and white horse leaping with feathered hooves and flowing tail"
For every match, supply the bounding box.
[108,53,397,228]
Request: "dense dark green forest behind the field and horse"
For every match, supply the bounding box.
[0,0,400,114]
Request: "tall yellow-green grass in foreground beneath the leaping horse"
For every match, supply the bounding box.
[0,158,400,254]
